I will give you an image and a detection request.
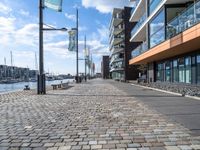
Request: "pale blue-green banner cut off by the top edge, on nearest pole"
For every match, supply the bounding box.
[44,0,62,12]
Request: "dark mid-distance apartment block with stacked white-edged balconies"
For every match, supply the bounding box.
[109,7,138,81]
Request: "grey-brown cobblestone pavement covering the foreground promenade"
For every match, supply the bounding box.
[0,79,200,150]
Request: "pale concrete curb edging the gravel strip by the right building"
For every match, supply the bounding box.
[131,83,200,101]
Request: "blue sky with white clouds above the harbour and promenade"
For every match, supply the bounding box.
[0,0,134,75]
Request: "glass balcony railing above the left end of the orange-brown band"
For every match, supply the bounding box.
[131,42,148,58]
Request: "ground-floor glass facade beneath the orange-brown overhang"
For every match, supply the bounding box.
[156,54,200,84]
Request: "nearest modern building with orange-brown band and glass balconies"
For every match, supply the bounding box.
[129,0,200,84]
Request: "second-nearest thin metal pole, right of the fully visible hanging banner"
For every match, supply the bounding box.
[76,8,79,83]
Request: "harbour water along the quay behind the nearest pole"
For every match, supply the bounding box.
[0,79,73,93]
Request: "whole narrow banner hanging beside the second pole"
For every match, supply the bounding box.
[68,30,77,52]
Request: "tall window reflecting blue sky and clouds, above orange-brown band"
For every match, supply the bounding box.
[149,9,165,48]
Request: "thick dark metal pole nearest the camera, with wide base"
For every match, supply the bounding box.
[37,0,46,94]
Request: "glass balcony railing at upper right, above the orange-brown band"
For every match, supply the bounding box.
[167,1,200,39]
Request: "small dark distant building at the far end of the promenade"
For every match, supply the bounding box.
[101,56,110,79]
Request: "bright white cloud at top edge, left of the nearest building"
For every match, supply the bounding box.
[82,0,130,13]
